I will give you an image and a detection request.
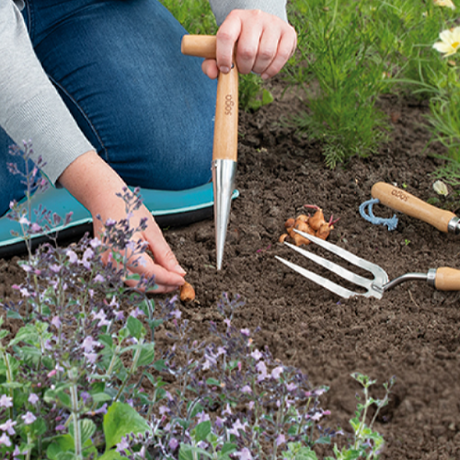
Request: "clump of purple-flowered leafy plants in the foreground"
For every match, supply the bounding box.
[0,145,393,460]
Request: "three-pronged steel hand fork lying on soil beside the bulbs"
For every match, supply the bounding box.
[275,230,460,299]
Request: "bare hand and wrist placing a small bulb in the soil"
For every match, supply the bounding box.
[59,151,185,294]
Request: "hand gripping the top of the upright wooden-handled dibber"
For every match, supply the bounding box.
[202,10,297,80]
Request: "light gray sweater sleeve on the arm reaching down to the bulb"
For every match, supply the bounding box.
[0,0,93,184]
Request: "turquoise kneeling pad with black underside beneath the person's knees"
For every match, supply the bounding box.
[0,182,239,258]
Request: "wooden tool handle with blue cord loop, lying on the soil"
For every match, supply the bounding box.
[371,182,456,233]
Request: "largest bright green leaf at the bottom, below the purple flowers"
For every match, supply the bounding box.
[103,402,150,452]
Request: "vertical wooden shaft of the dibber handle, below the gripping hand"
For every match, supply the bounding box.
[212,64,238,161]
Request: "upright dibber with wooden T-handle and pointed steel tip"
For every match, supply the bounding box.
[181,35,238,270]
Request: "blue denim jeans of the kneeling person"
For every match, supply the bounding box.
[0,0,216,215]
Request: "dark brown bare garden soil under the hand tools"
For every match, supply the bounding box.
[0,81,460,460]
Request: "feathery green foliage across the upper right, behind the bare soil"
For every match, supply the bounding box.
[287,0,460,171]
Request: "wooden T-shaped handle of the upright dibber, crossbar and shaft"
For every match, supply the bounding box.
[181,35,238,161]
